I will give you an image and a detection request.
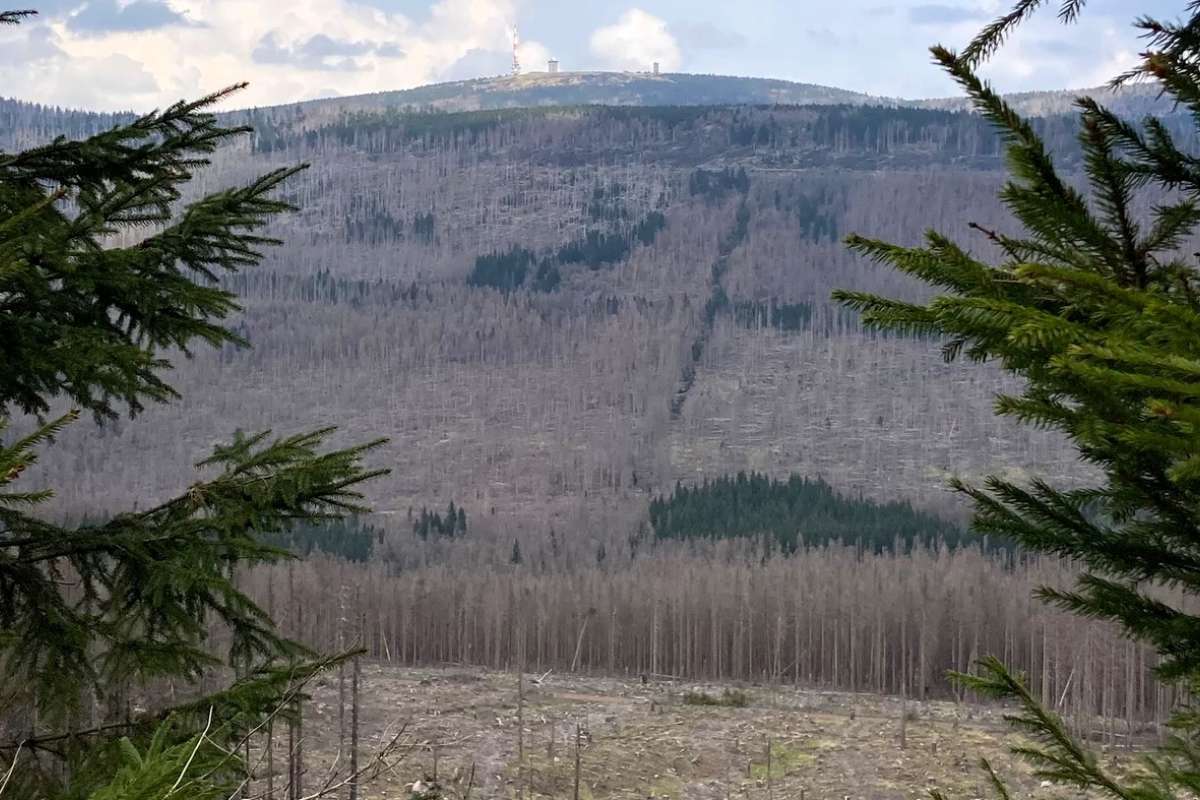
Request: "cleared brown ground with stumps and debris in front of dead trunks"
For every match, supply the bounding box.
[295,664,1147,800]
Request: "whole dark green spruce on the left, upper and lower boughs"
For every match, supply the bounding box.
[0,12,383,800]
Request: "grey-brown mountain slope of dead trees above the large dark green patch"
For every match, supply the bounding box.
[7,79,1188,544]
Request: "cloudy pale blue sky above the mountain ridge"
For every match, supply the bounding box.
[0,0,1184,112]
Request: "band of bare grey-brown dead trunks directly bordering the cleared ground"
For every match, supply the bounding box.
[247,546,1180,729]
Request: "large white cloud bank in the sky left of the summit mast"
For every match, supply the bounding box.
[0,0,546,110]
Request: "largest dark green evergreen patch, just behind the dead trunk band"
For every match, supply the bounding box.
[650,473,962,553]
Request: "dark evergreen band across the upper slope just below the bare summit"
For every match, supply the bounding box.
[246,99,1198,170]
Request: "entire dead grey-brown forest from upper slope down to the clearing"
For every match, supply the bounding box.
[0,89,1187,730]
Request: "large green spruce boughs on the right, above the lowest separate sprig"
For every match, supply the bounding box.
[838,37,1200,676]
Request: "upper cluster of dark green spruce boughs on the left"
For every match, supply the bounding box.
[0,88,304,417]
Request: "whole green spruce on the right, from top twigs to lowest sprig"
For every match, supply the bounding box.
[835,0,1200,800]
